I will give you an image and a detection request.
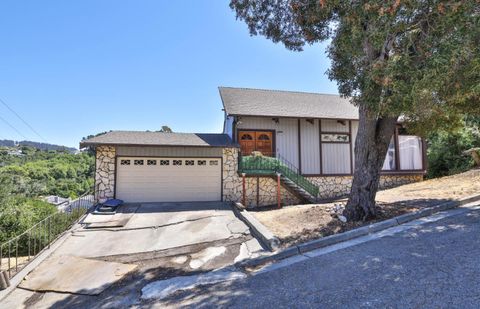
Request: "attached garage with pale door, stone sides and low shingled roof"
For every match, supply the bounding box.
[80,131,238,203]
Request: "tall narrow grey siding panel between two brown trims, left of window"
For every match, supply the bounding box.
[300,119,320,174]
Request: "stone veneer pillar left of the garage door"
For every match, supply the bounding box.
[95,146,115,202]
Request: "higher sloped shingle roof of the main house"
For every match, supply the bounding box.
[219,87,358,119]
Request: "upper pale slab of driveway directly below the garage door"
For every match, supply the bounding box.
[56,202,251,257]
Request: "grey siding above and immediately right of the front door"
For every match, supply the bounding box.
[237,116,299,168]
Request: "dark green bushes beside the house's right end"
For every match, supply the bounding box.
[427,121,480,178]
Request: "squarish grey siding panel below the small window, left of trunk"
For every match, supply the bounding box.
[322,143,350,174]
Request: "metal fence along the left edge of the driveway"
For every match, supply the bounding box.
[0,192,94,279]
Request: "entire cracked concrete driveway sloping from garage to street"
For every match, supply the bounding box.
[2,202,264,308]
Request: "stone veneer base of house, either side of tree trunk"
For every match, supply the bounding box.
[307,175,423,198]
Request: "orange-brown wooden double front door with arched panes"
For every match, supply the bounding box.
[238,131,274,156]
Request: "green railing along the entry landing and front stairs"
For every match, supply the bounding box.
[238,154,319,197]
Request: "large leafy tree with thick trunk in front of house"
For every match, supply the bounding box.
[230,0,480,220]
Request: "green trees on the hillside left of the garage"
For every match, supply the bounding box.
[0,146,95,245]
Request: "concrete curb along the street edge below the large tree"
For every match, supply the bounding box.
[237,194,480,268]
